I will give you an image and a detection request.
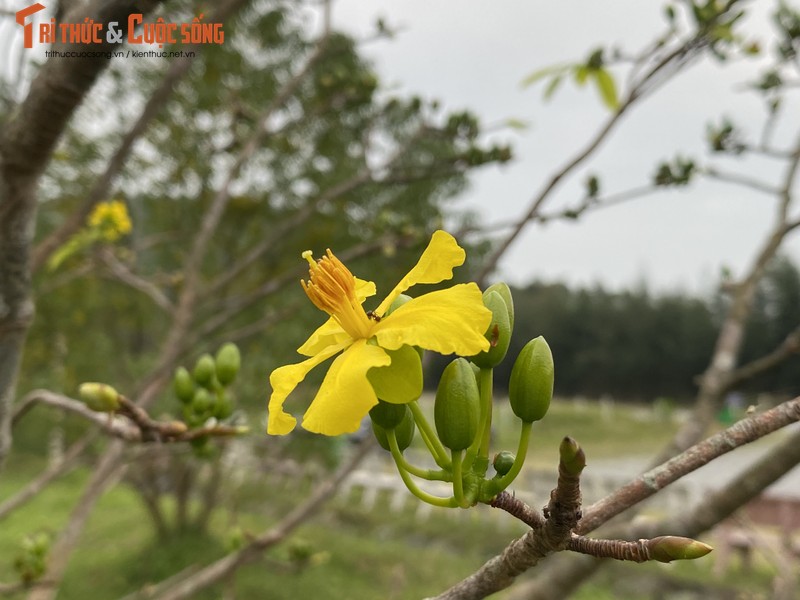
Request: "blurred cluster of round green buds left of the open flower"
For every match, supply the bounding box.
[172,343,241,455]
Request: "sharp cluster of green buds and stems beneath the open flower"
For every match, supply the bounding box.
[368,283,554,507]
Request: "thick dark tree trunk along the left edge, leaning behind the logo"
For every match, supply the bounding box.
[0,0,166,469]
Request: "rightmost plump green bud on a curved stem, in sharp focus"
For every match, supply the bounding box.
[508,336,555,423]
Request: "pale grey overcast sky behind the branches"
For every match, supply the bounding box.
[326,0,800,292]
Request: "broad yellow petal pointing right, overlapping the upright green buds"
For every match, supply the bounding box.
[373,283,492,356]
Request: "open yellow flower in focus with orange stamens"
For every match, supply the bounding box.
[267,231,492,435]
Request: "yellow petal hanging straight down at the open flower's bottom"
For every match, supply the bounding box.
[303,340,391,435]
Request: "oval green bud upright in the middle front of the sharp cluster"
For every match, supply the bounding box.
[433,356,478,450]
